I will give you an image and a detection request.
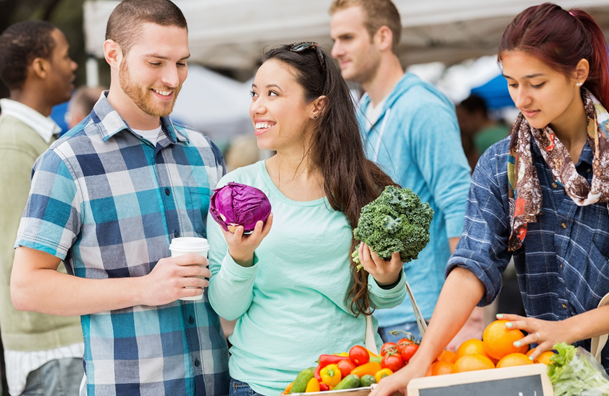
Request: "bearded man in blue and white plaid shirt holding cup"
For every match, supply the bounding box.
[11,0,229,396]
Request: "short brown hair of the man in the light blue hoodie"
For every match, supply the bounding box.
[330,0,402,54]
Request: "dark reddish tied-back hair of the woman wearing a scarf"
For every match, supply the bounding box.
[498,3,609,108]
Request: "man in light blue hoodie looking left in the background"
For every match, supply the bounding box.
[330,0,483,350]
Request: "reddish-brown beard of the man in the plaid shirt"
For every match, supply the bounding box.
[118,59,181,117]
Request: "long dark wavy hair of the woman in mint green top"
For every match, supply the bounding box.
[264,45,396,315]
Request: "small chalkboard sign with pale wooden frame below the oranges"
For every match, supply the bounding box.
[408,364,554,396]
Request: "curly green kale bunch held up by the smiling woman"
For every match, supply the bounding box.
[353,186,433,268]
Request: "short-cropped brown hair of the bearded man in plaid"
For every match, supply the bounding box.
[106,0,188,55]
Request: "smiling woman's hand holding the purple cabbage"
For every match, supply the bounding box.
[222,213,273,267]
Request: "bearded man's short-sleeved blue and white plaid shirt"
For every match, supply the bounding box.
[16,96,230,396]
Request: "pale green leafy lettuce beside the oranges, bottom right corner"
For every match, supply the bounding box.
[548,342,609,396]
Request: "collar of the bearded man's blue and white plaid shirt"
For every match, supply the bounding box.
[91,91,189,143]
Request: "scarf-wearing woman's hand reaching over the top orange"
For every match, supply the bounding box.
[497,314,578,360]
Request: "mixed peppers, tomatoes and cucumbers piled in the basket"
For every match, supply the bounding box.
[283,338,418,395]
